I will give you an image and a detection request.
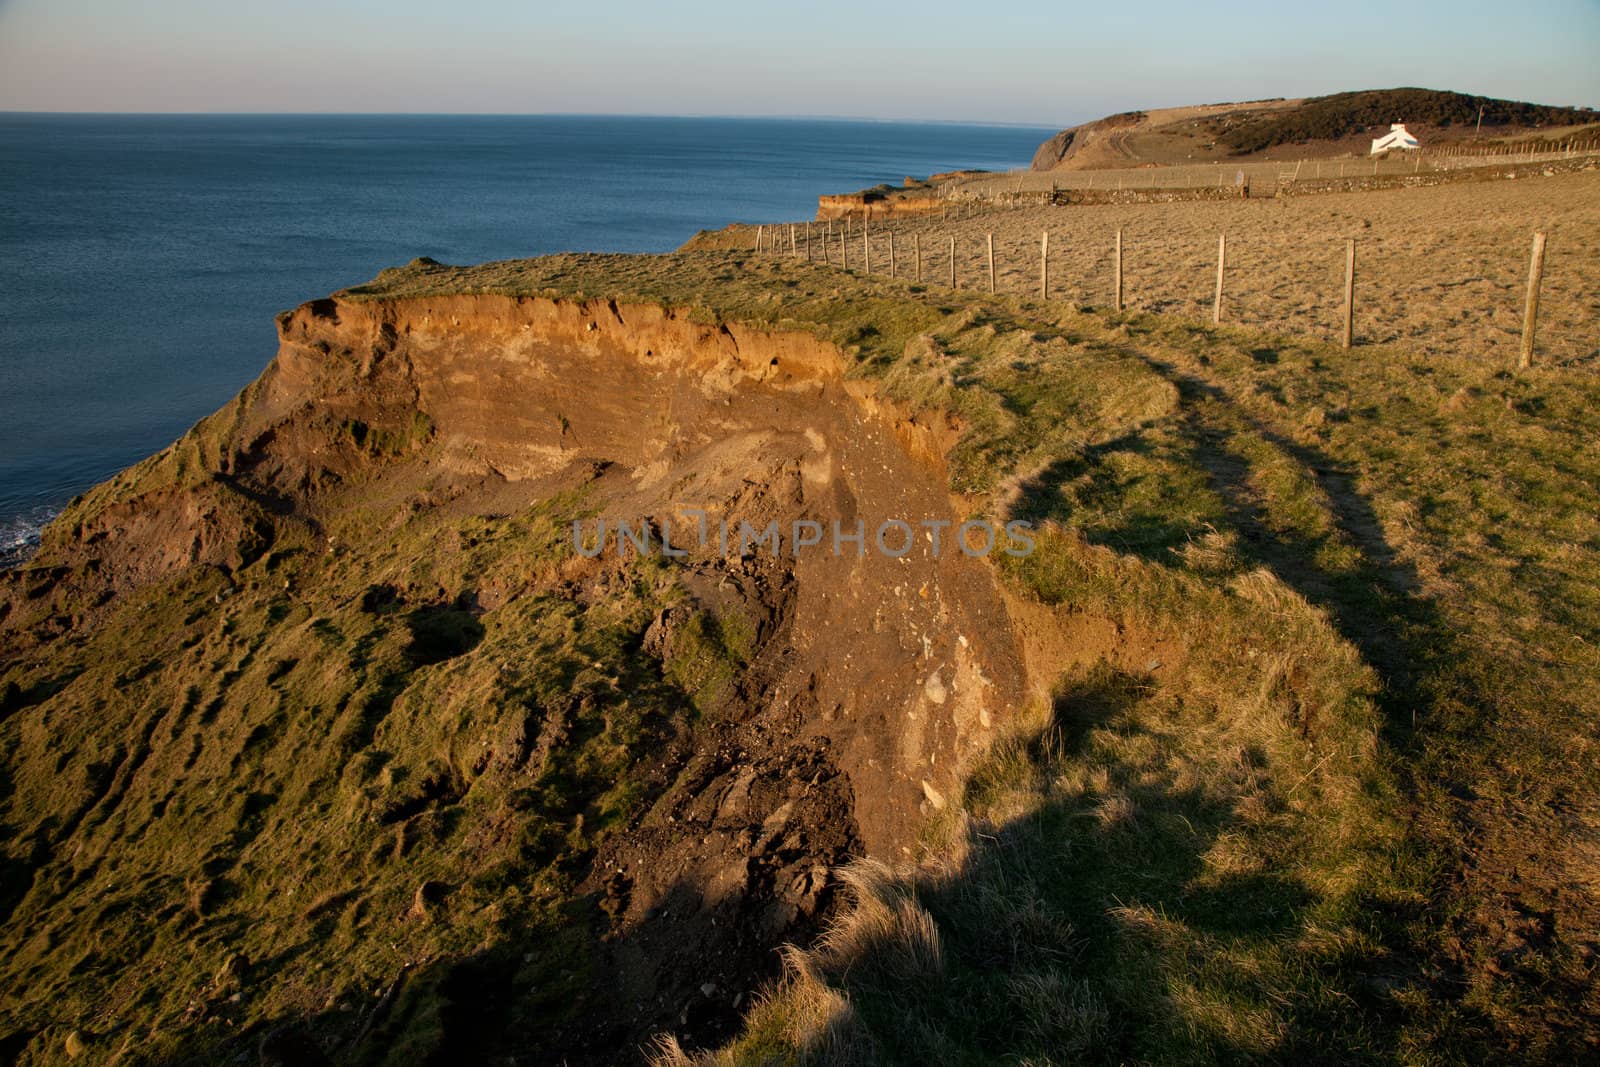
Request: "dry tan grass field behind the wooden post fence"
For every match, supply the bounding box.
[694,168,1600,366]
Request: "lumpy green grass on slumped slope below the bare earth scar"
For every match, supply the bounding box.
[6,489,720,1062]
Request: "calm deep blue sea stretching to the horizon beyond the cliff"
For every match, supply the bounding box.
[0,114,1054,557]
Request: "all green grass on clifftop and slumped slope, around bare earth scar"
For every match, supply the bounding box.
[0,251,1600,1062]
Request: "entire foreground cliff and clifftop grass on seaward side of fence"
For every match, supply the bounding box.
[0,253,1600,1062]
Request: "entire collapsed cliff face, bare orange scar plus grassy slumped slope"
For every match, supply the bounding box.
[0,289,1024,1059]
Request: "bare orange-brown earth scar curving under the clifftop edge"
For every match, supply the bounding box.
[262,296,1022,854]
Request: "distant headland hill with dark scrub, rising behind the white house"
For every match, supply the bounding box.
[1032,88,1600,171]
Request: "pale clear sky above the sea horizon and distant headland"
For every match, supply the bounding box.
[0,0,1600,125]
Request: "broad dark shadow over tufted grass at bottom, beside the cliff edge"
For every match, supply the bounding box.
[793,664,1382,1064]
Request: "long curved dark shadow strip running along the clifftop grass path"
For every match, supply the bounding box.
[1019,350,1594,1057]
